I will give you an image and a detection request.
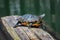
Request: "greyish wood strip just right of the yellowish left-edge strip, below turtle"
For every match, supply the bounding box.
[14,27,30,40]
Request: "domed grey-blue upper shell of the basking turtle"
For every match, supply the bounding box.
[22,14,39,22]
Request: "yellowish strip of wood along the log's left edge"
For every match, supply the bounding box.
[1,18,21,40]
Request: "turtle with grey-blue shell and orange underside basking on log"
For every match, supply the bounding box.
[14,14,45,28]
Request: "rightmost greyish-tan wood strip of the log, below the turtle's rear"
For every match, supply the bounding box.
[31,28,54,40]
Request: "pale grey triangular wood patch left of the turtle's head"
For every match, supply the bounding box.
[3,16,18,27]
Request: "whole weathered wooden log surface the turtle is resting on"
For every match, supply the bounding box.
[1,16,55,40]
